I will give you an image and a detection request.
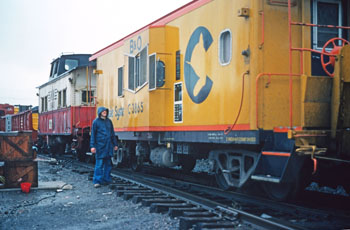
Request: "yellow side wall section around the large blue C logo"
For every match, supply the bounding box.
[169,1,250,125]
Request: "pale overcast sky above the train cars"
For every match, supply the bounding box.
[0,0,191,106]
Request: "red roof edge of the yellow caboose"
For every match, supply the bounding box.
[89,0,213,61]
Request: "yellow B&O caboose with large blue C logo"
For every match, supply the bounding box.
[90,0,350,200]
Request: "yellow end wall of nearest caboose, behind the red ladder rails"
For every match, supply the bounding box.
[257,1,311,129]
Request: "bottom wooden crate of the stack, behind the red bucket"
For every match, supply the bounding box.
[4,161,38,188]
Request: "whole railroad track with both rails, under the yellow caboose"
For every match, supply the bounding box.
[49,155,349,229]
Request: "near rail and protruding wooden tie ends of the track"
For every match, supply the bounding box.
[113,171,298,229]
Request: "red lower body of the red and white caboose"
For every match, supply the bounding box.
[39,106,96,135]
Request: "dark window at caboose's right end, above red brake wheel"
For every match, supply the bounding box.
[313,0,342,49]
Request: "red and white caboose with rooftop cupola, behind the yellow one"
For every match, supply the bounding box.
[38,54,96,160]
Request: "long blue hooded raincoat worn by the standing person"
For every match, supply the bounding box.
[90,107,117,159]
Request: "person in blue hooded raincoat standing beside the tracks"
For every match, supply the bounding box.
[90,107,118,188]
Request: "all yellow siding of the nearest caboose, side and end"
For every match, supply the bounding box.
[97,0,323,132]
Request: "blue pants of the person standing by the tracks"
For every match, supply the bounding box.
[93,157,112,184]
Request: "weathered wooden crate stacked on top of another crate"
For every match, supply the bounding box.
[0,132,36,161]
